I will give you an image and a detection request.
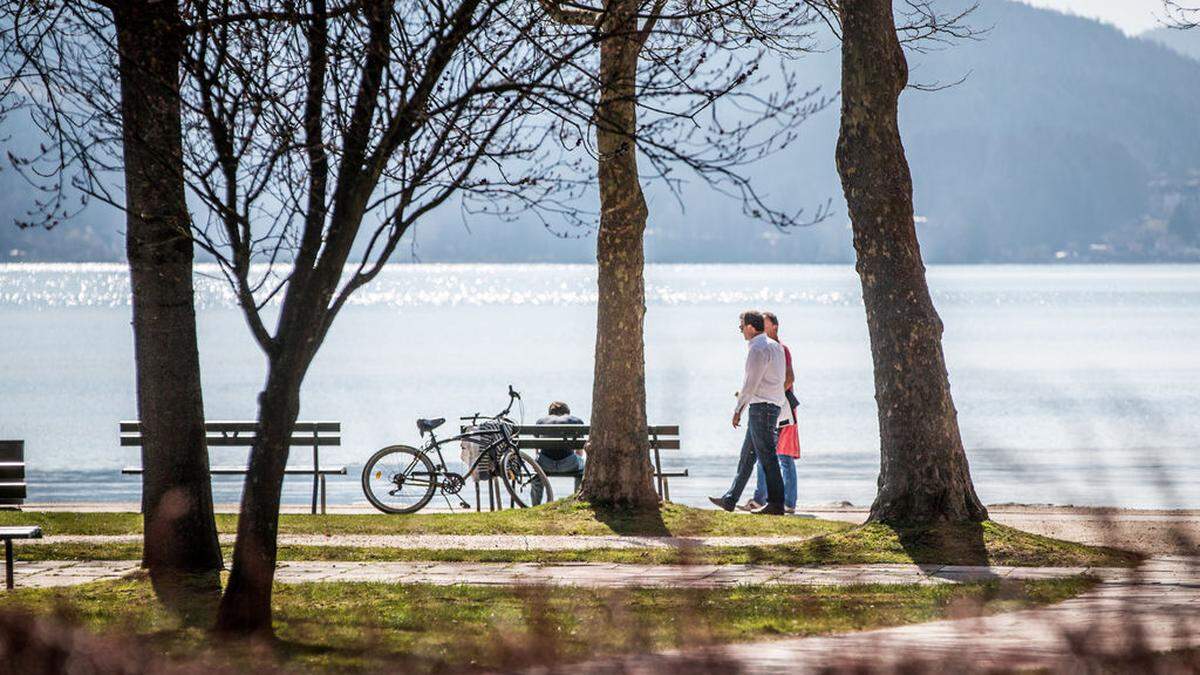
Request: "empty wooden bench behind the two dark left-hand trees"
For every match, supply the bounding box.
[120,422,346,513]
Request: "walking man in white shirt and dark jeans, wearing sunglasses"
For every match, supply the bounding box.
[708,311,787,515]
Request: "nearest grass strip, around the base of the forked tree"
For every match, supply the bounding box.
[5,569,1097,673]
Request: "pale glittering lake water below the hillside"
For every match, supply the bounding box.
[0,264,1200,508]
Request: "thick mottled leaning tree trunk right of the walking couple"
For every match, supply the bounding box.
[838,0,988,524]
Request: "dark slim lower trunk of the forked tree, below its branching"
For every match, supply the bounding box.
[216,360,304,637]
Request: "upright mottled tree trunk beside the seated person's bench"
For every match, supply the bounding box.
[580,0,658,508]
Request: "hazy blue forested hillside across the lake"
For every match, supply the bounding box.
[0,1,1200,262]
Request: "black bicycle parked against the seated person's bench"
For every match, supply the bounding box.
[362,384,554,513]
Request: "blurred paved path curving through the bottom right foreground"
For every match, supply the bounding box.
[535,557,1200,674]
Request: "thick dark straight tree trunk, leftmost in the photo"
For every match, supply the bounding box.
[113,1,222,601]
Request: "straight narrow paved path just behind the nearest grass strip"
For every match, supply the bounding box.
[4,561,1124,589]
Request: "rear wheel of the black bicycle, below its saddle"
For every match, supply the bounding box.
[362,446,438,513]
